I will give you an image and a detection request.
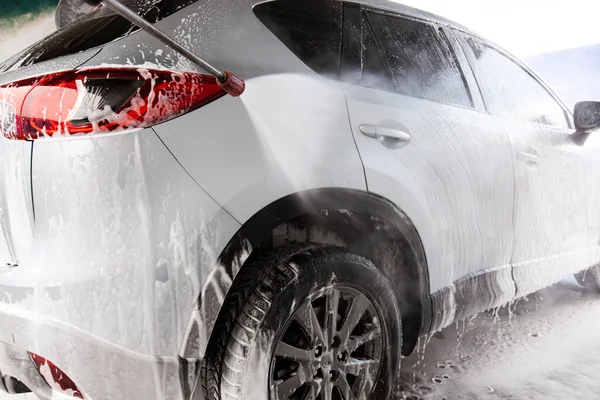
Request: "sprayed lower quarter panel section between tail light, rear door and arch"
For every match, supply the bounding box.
[155,74,366,223]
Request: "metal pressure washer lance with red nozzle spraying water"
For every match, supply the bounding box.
[84,0,246,97]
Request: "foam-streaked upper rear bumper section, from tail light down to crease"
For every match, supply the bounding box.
[0,129,239,355]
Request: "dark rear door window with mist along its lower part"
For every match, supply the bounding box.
[363,12,473,107]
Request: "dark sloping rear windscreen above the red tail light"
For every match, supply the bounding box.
[0,0,197,71]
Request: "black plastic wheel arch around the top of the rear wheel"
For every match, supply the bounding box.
[180,188,431,358]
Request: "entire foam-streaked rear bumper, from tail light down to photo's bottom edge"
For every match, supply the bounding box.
[0,129,239,400]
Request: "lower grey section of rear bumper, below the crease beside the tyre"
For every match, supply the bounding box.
[0,304,189,400]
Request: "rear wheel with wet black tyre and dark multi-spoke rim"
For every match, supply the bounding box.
[203,247,402,400]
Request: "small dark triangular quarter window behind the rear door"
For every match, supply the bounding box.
[254,0,343,76]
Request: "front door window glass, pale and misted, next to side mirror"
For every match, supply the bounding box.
[466,37,569,128]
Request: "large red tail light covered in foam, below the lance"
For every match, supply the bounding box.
[0,68,226,140]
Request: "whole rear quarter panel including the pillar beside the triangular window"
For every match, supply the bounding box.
[75,0,366,223]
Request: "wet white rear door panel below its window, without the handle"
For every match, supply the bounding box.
[345,85,514,297]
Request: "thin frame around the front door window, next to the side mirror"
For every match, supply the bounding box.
[458,33,574,130]
